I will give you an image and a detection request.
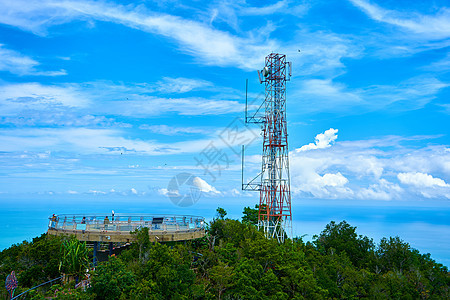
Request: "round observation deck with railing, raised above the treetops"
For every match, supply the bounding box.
[47,214,205,243]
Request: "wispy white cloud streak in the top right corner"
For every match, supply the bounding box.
[350,0,450,39]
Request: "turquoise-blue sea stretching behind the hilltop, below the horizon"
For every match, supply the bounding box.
[0,195,450,267]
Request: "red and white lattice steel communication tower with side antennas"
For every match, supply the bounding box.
[242,53,292,242]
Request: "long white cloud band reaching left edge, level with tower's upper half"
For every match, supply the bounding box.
[0,82,242,118]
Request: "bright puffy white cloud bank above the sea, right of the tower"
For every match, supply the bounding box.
[290,127,450,200]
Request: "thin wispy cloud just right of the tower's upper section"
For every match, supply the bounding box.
[293,75,450,114]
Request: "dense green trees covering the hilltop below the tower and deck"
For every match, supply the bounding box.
[0,207,450,299]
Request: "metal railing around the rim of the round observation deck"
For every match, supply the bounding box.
[48,214,205,232]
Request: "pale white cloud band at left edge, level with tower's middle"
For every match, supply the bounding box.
[0,128,254,159]
